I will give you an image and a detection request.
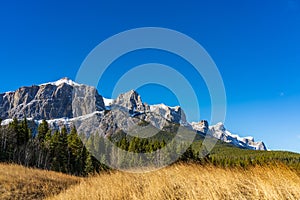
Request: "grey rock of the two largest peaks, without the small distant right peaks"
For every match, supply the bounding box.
[0,79,188,135]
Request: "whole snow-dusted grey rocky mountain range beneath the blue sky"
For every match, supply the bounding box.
[0,78,266,150]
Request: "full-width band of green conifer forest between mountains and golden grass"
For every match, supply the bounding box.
[0,118,300,176]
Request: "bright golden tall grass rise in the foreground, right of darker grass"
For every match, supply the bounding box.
[49,164,300,200]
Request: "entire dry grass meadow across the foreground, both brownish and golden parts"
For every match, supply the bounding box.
[0,163,300,200]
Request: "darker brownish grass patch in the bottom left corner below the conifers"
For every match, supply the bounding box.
[0,164,80,200]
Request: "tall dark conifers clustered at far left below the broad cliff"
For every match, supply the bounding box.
[0,118,100,176]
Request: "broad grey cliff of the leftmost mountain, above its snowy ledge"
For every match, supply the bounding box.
[0,78,105,119]
